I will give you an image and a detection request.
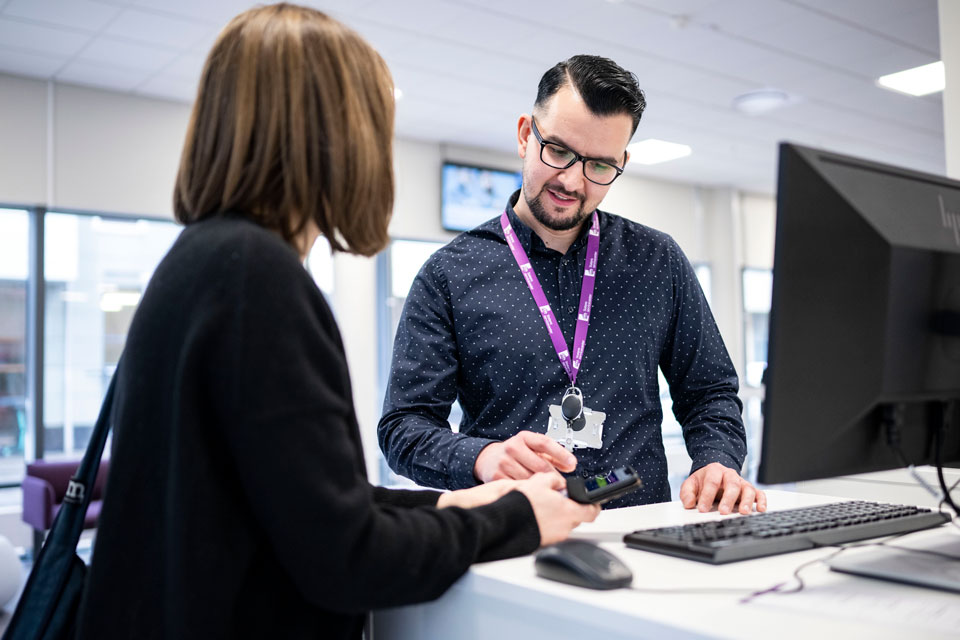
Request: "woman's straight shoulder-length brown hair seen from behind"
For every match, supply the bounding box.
[173,4,394,256]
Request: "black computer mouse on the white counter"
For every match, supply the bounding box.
[534,540,633,589]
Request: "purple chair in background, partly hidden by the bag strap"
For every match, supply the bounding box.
[22,459,110,556]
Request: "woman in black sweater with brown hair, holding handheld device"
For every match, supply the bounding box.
[79,5,597,639]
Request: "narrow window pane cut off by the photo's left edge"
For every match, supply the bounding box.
[0,209,30,483]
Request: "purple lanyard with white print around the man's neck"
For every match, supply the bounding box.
[500,211,600,386]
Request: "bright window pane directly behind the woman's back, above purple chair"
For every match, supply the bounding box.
[43,212,180,458]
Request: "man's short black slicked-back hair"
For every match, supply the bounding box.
[534,55,647,136]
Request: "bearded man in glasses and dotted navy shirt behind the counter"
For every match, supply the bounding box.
[379,55,766,513]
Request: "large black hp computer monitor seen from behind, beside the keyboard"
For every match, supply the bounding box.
[758,144,960,483]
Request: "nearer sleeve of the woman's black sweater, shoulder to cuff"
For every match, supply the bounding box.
[212,234,540,612]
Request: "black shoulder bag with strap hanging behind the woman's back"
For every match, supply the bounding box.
[3,369,119,640]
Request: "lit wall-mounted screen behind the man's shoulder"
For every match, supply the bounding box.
[440,162,521,231]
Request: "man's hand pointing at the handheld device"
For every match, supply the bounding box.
[473,431,577,482]
